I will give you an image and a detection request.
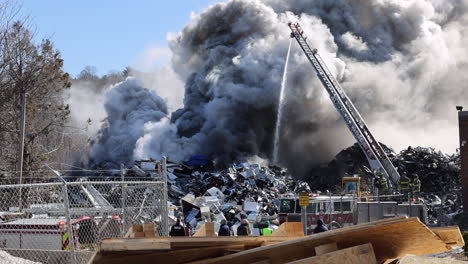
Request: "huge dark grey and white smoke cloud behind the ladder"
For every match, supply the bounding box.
[88,0,468,176]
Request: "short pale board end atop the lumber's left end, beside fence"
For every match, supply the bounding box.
[100,237,171,251]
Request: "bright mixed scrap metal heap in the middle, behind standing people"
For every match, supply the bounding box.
[130,156,310,229]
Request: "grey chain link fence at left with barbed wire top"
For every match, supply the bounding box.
[0,160,169,264]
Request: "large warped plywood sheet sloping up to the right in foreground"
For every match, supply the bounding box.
[188,217,449,264]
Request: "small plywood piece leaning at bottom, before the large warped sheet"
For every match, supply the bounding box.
[289,243,377,264]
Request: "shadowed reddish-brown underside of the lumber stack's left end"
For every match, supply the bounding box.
[92,246,243,264]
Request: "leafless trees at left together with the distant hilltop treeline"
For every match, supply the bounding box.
[0,1,130,177]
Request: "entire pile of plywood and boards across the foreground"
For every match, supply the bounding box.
[93,217,463,264]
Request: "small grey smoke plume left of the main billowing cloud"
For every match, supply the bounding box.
[90,78,168,165]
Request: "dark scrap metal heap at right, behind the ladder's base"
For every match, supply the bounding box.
[307,144,462,224]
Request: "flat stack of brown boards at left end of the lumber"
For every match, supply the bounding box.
[92,236,304,264]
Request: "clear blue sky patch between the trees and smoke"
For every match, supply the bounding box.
[20,0,225,76]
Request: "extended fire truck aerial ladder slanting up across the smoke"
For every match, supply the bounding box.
[288,22,400,188]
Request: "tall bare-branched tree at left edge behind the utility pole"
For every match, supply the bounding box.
[0,19,70,170]
